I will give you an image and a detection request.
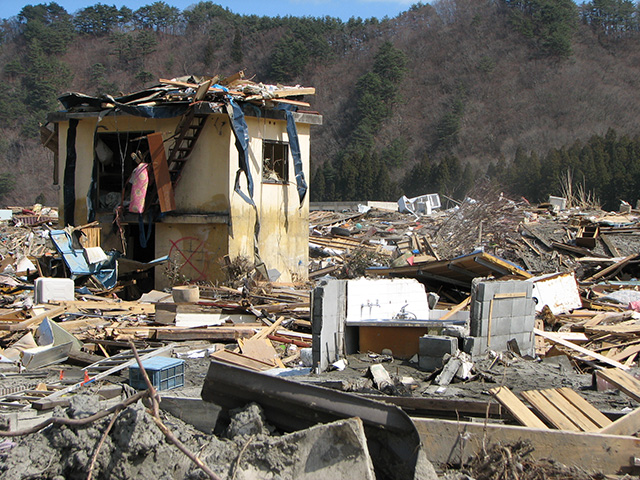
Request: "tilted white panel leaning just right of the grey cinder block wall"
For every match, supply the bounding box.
[527,272,582,315]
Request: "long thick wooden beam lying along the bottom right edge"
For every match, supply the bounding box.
[412,418,640,475]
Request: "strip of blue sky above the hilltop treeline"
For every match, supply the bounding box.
[0,0,418,21]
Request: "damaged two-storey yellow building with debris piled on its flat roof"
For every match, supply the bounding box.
[42,72,322,288]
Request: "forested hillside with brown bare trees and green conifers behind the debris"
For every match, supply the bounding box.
[0,0,640,208]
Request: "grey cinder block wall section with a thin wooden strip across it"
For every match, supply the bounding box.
[470,279,535,355]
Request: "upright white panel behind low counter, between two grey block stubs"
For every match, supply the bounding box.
[346,278,429,323]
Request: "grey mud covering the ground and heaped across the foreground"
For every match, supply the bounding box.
[0,348,637,480]
